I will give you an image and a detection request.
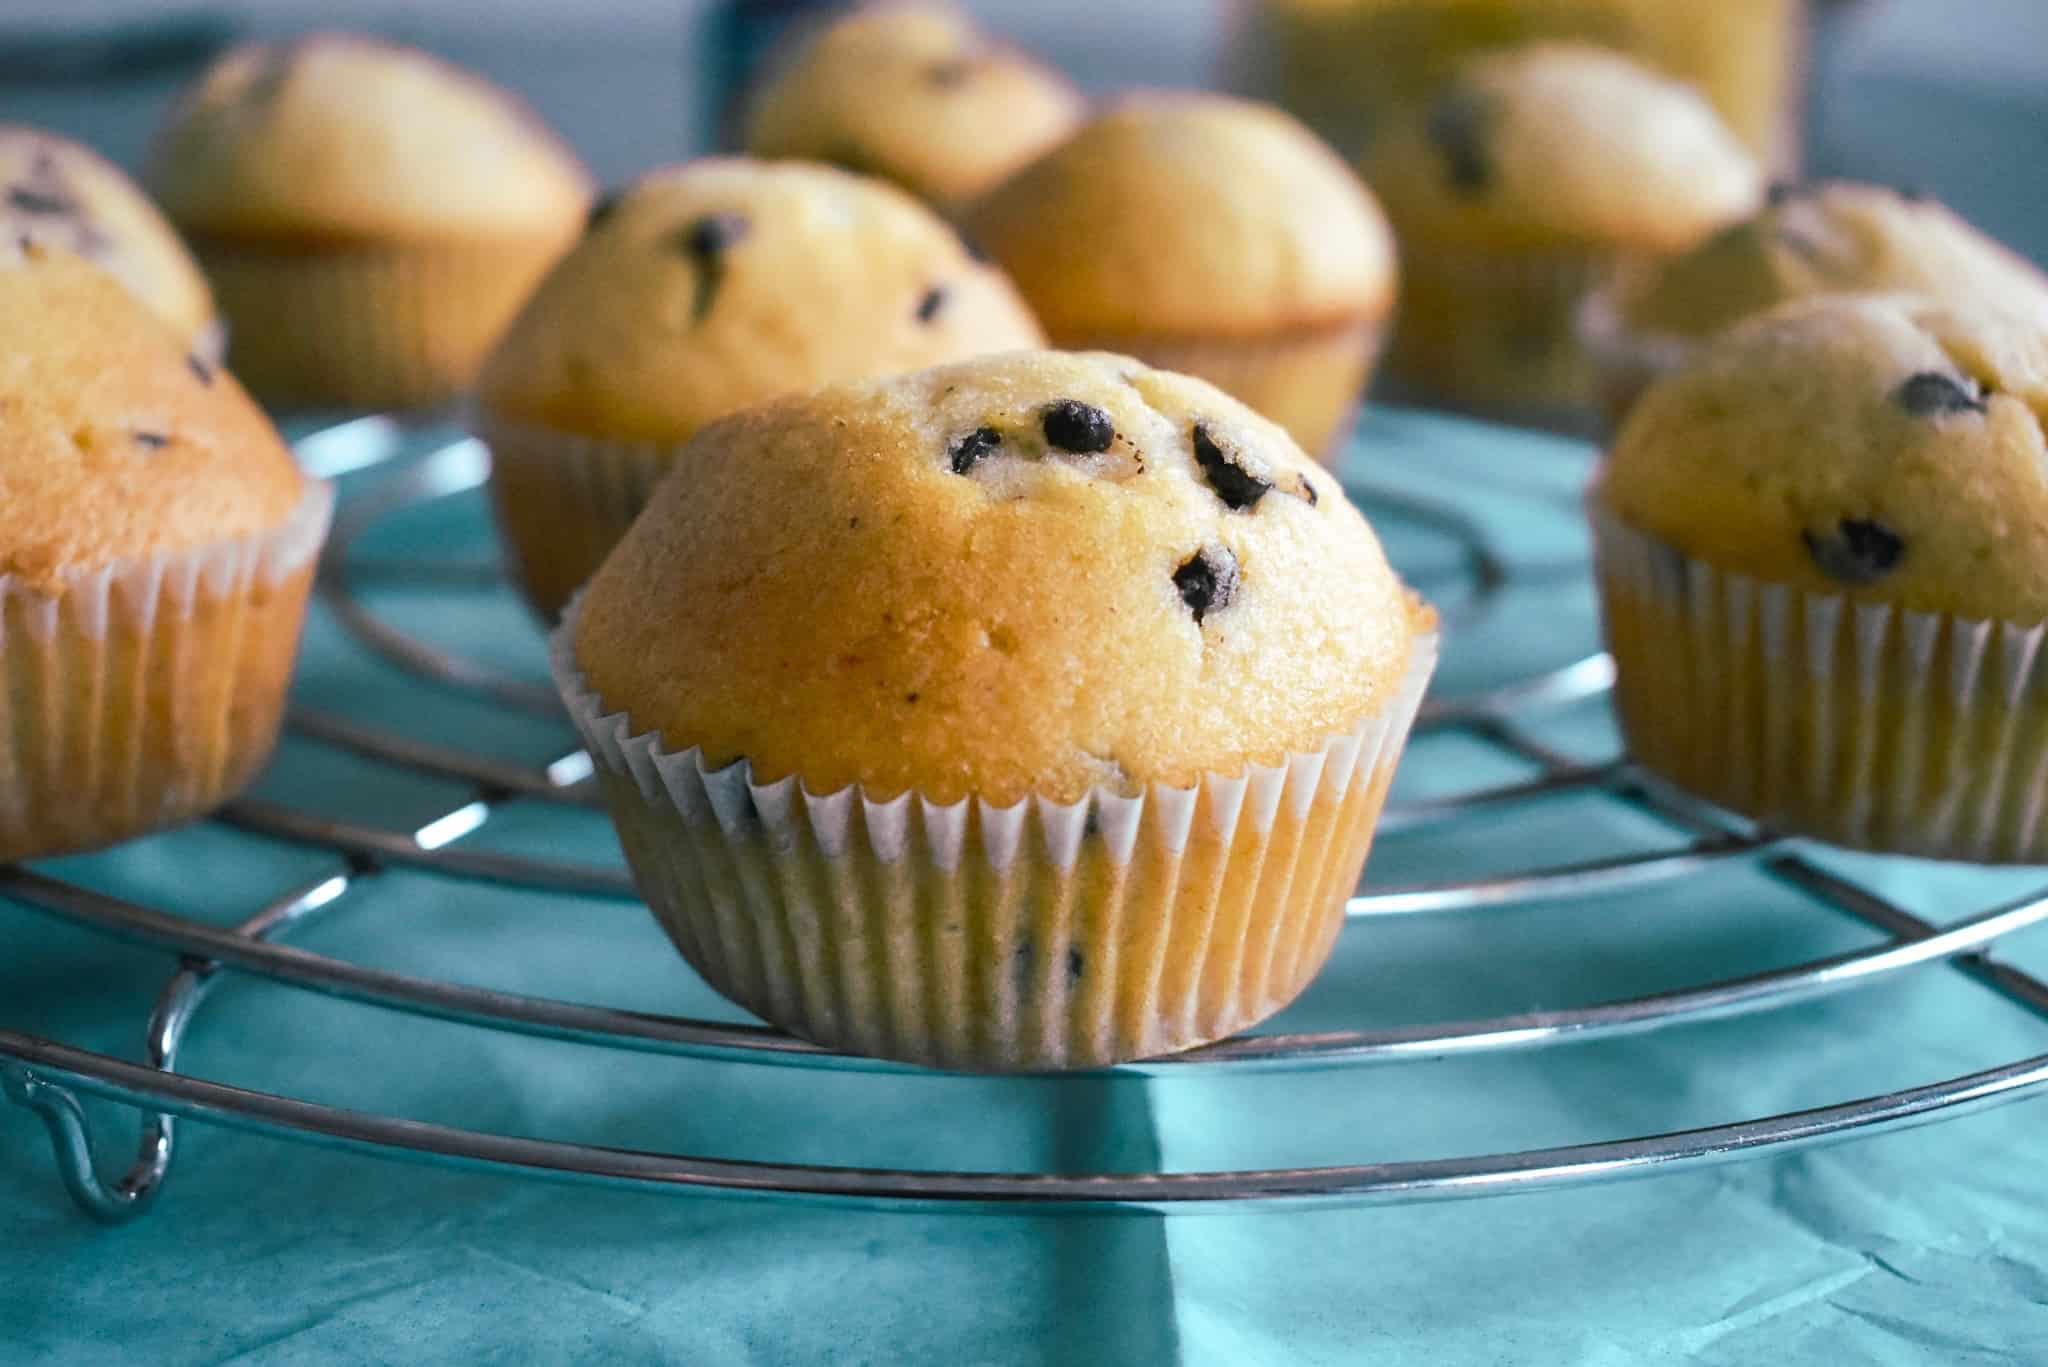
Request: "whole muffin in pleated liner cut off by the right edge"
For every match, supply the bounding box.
[1591,295,2048,863]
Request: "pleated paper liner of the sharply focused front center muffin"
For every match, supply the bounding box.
[553,607,1436,1072]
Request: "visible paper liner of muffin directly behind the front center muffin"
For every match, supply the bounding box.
[473,414,682,623]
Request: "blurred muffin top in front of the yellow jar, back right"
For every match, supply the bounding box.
[1364,43,1763,252]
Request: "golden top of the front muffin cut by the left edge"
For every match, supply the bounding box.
[0,249,305,592]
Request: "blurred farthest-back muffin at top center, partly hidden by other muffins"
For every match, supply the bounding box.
[748,2,1085,209]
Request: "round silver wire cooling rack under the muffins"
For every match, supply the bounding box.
[0,416,2048,1221]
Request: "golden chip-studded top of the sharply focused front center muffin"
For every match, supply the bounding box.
[573,353,1434,803]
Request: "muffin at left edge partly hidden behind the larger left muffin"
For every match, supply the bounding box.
[0,123,227,365]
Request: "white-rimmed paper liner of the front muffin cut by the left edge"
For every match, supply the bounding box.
[0,484,334,863]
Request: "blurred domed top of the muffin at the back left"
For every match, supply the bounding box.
[147,33,590,244]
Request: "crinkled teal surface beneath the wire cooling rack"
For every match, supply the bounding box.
[0,412,2048,1365]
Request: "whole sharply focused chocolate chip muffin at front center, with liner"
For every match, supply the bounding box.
[553,353,1436,1070]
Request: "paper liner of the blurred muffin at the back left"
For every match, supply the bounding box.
[193,234,569,408]
